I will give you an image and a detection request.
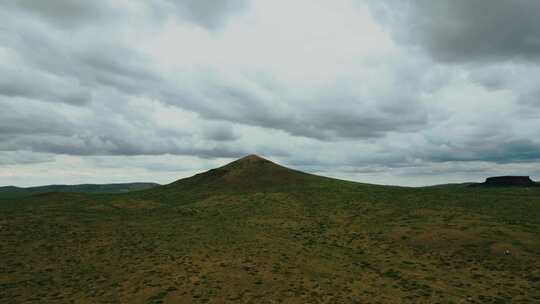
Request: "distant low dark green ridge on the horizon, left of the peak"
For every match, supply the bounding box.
[0,183,159,198]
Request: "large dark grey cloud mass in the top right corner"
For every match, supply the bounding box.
[372,0,540,63]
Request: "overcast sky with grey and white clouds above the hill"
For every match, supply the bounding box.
[0,0,540,186]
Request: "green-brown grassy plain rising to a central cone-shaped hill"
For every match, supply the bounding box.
[0,156,540,303]
